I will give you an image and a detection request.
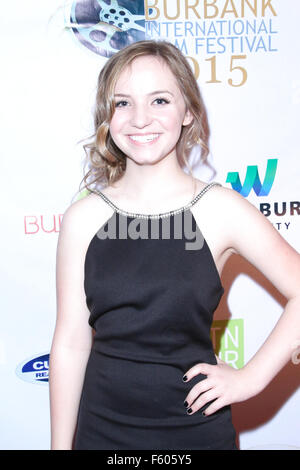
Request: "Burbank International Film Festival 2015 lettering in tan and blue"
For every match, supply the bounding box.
[145,0,279,88]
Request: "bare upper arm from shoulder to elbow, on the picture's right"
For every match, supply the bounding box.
[209,183,300,298]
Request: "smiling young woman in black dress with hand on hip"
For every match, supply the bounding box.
[50,41,300,449]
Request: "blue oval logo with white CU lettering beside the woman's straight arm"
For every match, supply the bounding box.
[16,354,49,384]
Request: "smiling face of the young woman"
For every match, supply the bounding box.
[109,56,193,164]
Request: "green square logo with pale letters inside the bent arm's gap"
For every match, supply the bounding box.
[210,319,244,369]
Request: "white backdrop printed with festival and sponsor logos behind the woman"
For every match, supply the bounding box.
[0,0,300,450]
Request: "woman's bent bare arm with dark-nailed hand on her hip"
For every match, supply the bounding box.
[185,187,300,415]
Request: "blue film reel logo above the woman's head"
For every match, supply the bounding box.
[65,0,146,57]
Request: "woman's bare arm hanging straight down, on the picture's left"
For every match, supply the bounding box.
[49,200,92,450]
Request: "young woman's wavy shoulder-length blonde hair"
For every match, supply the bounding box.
[79,40,209,192]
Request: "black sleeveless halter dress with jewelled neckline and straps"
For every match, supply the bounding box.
[74,182,236,450]
